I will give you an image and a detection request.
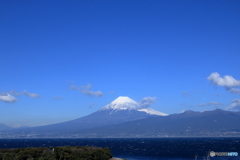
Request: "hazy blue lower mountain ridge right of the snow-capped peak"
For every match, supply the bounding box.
[74,109,240,137]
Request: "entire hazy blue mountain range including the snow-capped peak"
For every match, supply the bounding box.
[0,97,240,138]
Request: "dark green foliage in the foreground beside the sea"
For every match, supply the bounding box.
[0,146,112,160]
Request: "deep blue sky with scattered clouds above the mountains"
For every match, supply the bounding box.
[0,0,240,127]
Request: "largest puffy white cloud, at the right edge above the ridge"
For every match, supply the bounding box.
[207,72,240,88]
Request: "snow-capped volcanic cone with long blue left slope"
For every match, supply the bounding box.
[4,96,168,135]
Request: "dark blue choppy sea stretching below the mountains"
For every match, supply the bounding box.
[0,137,240,160]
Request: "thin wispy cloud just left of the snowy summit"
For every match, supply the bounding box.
[70,84,103,97]
